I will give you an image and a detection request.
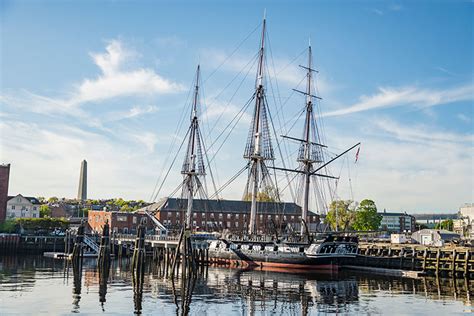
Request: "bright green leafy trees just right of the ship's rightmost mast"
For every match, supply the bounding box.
[326,199,382,231]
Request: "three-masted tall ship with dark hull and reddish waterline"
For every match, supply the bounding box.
[163,14,359,271]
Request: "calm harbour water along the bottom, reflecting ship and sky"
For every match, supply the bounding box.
[0,257,474,315]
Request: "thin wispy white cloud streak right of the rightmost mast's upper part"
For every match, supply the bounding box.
[323,84,474,116]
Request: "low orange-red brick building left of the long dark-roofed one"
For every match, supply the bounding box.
[87,210,155,234]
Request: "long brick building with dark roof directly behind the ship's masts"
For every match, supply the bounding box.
[139,198,319,232]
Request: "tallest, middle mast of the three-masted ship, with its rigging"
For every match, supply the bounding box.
[244,16,274,235]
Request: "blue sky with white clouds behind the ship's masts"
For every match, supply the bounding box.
[0,0,474,213]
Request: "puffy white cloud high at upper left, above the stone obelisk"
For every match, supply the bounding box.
[0,40,184,117]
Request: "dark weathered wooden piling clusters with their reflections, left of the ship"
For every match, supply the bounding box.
[70,218,209,315]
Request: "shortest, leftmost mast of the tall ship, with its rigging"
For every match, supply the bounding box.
[181,65,206,229]
